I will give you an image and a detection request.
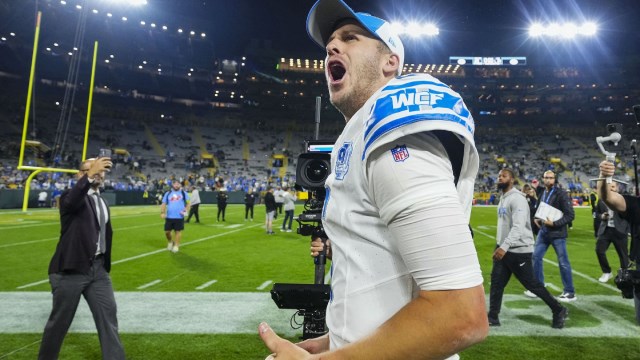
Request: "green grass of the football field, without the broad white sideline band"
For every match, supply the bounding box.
[0,205,640,359]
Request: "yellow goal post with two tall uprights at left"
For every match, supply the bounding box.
[17,11,98,212]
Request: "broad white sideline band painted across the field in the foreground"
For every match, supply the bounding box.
[0,291,640,339]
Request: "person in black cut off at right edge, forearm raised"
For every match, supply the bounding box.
[598,160,640,324]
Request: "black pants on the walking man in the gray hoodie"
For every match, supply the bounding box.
[489,252,562,318]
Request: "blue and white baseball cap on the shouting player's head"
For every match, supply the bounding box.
[307,0,404,75]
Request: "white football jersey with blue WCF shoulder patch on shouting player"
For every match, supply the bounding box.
[322,74,482,354]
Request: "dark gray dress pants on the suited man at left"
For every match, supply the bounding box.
[38,258,125,359]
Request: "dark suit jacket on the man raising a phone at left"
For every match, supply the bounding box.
[49,174,113,274]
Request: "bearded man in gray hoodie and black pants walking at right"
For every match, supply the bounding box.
[488,168,569,329]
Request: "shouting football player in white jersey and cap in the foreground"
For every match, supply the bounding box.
[258,0,489,360]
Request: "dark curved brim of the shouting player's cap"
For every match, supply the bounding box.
[307,0,362,48]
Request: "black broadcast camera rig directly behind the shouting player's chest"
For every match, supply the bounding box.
[271,141,333,340]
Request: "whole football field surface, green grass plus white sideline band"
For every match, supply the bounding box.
[0,205,640,360]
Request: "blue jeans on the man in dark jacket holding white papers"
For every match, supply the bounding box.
[533,230,576,294]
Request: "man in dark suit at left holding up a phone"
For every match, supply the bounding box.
[38,157,125,359]
